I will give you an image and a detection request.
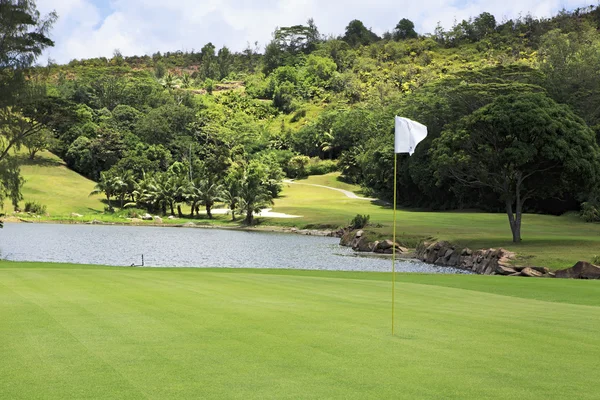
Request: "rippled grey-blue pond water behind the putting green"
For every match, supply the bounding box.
[0,223,462,273]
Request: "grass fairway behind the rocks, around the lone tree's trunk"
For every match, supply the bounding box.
[274,175,600,268]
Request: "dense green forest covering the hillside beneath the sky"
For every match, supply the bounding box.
[4,0,600,233]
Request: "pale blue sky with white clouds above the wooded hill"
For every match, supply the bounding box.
[37,0,597,64]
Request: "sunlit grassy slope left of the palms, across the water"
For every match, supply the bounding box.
[5,152,104,215]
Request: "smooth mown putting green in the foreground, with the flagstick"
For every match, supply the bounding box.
[0,262,600,399]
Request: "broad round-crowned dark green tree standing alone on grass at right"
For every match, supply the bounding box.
[431,93,600,243]
